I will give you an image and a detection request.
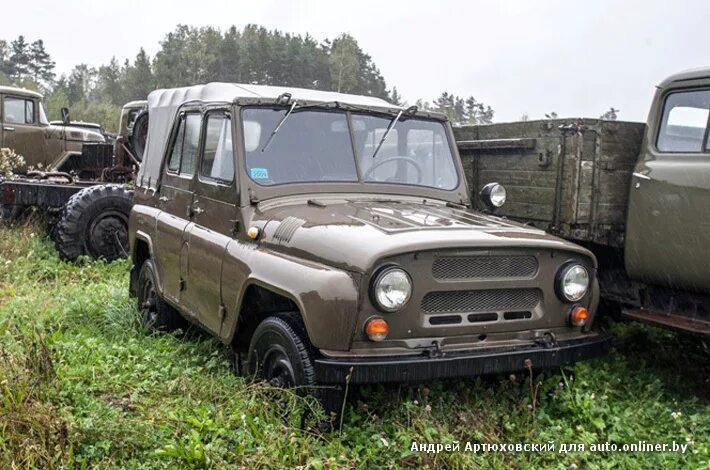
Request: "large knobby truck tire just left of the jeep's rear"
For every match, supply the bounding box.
[54,184,133,261]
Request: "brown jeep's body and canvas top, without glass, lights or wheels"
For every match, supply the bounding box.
[129,84,608,383]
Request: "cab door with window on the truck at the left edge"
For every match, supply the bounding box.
[2,95,49,166]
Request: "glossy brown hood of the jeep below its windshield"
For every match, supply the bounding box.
[251,196,593,272]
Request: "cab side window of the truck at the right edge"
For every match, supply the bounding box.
[656,90,710,152]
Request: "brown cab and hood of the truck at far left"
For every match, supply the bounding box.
[0,86,105,171]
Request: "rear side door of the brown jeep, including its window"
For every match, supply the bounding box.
[155,111,202,302]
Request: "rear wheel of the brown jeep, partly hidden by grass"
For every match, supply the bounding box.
[137,259,187,332]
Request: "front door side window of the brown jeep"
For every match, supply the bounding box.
[200,113,234,183]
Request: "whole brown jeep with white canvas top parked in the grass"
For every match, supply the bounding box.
[129,83,609,406]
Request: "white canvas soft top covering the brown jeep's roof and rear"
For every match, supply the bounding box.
[137,83,401,189]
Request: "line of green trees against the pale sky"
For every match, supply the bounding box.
[0,25,494,131]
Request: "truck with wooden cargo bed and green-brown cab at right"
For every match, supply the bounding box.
[454,69,710,335]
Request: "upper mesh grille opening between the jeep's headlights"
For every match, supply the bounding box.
[432,255,537,279]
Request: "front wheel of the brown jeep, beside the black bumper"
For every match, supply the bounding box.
[247,314,343,413]
